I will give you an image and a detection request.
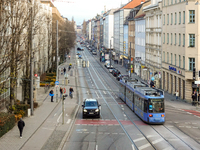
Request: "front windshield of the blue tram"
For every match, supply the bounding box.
[149,99,164,113]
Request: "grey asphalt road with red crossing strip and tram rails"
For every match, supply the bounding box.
[63,41,200,150]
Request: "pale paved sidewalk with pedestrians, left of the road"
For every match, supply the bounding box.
[0,52,75,150]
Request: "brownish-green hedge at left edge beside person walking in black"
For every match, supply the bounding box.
[0,112,15,137]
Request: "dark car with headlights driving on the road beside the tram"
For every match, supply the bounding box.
[82,99,101,118]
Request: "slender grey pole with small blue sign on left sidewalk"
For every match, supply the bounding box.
[56,20,58,102]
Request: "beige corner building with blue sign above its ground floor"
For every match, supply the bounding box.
[162,0,200,100]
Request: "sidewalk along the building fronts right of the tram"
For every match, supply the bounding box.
[96,55,200,111]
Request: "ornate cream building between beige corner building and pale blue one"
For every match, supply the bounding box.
[143,0,162,88]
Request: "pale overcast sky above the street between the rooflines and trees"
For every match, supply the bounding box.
[54,0,130,25]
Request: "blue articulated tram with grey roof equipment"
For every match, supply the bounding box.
[119,78,165,124]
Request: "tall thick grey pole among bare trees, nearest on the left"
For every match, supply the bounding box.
[30,6,33,116]
